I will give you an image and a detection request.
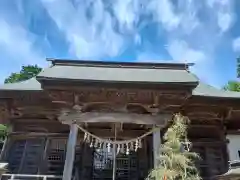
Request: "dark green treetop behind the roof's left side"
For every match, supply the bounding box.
[4,65,42,83]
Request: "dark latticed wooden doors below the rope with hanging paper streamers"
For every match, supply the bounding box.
[77,138,152,180]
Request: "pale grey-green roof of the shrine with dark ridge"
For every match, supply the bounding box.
[0,61,240,98]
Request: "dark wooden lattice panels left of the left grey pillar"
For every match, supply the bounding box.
[6,137,67,175]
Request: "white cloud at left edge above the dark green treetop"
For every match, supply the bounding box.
[0,15,47,83]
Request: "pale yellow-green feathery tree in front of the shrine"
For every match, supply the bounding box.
[148,114,201,180]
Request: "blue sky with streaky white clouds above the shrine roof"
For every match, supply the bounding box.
[0,0,240,87]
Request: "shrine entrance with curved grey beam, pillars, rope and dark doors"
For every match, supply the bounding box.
[59,107,170,180]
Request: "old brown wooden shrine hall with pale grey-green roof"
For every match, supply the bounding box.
[0,59,240,180]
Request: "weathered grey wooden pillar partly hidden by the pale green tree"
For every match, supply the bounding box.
[153,130,161,168]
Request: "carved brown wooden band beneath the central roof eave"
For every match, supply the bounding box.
[49,87,190,107]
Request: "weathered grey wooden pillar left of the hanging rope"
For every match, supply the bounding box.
[63,123,78,180]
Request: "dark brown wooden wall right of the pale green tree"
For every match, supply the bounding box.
[189,125,228,180]
